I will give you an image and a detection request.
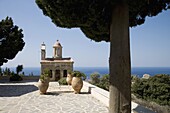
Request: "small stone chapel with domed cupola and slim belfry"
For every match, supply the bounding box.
[40,40,74,81]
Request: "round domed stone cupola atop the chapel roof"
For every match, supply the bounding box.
[53,40,62,58]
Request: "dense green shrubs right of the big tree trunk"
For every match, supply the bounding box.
[132,74,170,106]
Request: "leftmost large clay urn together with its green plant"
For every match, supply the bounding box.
[38,69,50,94]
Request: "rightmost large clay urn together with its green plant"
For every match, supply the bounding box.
[71,71,86,94]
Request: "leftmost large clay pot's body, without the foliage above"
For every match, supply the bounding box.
[38,78,49,94]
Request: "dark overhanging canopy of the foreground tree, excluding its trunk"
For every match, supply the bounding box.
[36,0,170,42]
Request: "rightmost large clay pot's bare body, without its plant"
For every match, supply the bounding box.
[71,77,83,94]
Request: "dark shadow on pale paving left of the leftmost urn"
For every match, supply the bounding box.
[0,85,38,97]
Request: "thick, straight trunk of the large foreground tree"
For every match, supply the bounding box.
[109,3,131,113]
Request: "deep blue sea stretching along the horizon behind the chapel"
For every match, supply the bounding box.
[2,67,170,79]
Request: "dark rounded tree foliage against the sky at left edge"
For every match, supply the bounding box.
[0,17,25,66]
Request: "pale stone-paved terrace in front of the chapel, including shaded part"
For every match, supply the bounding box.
[0,81,155,113]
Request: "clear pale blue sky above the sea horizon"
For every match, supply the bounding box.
[0,0,170,67]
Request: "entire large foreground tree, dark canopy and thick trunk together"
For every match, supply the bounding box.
[36,0,170,113]
